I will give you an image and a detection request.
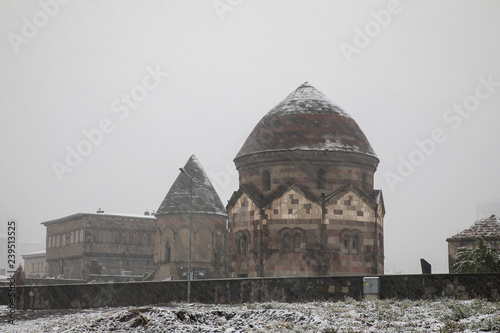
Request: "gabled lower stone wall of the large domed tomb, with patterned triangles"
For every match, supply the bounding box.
[228,186,384,278]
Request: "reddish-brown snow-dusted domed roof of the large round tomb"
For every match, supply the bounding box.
[236,82,377,159]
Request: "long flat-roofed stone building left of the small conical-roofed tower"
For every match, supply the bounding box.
[42,210,156,280]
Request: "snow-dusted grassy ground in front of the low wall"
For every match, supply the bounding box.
[0,299,500,332]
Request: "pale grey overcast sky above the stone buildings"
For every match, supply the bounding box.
[0,0,500,273]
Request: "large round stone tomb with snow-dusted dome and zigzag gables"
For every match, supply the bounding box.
[227,83,385,277]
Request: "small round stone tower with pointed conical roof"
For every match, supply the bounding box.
[155,155,227,280]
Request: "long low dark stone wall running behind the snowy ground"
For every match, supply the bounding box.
[0,273,500,309]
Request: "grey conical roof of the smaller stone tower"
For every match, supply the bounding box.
[156,155,227,216]
